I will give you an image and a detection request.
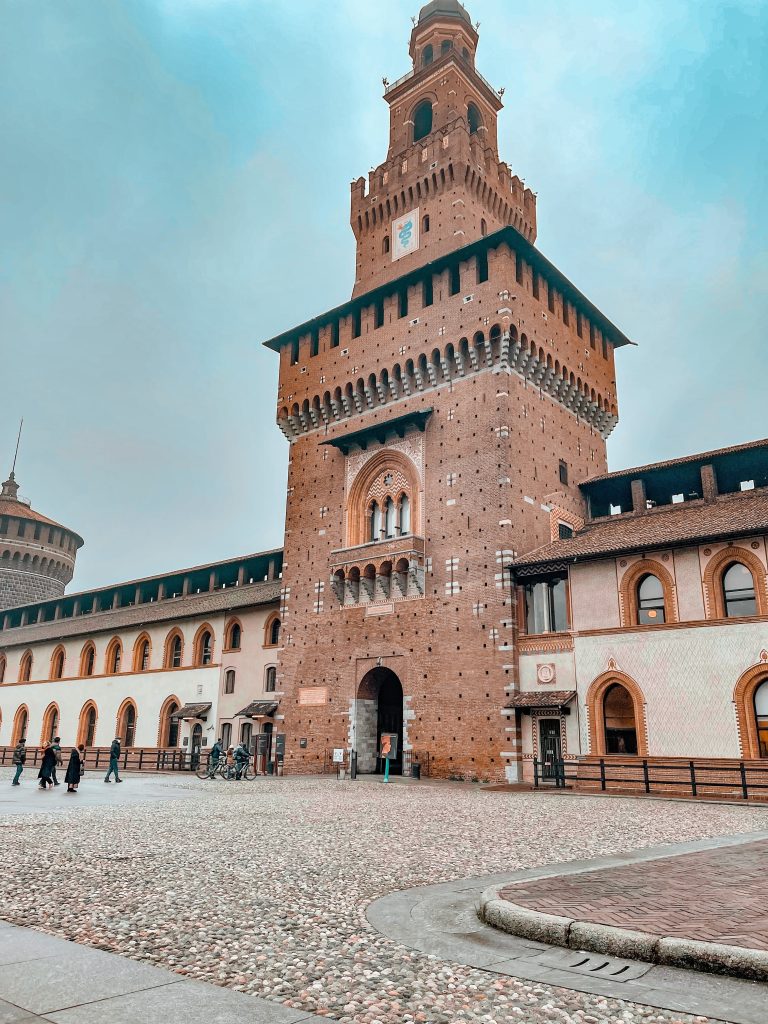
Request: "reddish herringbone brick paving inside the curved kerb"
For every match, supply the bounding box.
[501,841,768,949]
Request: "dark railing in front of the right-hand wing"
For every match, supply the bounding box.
[534,758,768,800]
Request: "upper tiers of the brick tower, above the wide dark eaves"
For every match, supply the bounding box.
[350,0,536,295]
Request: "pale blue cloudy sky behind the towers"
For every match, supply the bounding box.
[0,0,768,590]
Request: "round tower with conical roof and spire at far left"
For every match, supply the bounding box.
[0,472,83,609]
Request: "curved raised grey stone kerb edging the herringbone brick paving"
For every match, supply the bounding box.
[477,884,768,981]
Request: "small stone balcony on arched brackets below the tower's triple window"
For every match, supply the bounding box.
[330,535,426,605]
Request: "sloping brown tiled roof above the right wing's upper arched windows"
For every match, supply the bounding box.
[514,488,768,569]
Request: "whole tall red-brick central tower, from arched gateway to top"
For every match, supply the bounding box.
[266,0,628,779]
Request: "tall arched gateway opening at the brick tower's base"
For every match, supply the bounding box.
[355,667,402,775]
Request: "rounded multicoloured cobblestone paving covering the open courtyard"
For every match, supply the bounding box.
[0,773,768,1024]
